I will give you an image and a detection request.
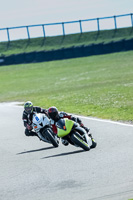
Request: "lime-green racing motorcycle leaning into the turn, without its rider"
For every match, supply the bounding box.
[56,118,97,151]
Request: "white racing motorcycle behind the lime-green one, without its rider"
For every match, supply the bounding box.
[32,113,59,147]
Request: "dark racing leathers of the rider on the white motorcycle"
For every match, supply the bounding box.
[22,106,47,136]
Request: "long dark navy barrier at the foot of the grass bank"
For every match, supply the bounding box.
[0,39,133,66]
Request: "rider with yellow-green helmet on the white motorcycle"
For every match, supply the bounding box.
[22,101,47,137]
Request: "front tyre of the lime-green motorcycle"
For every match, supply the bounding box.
[71,132,90,151]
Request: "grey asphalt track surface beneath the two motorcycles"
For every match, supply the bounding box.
[0,104,133,200]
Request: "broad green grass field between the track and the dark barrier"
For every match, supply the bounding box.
[0,51,133,121]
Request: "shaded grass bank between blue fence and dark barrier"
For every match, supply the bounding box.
[0,28,133,55]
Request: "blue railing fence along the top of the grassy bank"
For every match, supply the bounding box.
[0,13,133,42]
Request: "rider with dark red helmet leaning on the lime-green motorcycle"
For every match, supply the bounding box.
[48,106,93,146]
